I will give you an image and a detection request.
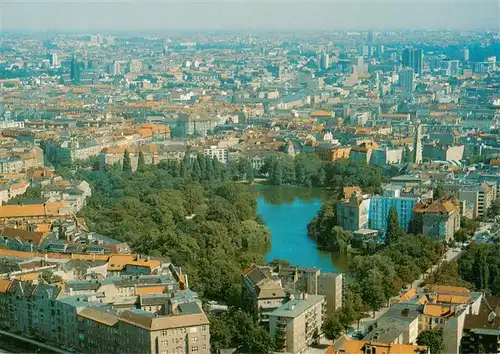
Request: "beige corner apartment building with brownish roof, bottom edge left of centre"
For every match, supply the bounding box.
[78,303,210,354]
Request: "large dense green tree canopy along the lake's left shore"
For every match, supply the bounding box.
[79,163,270,305]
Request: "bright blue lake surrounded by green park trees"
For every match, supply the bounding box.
[257,186,348,272]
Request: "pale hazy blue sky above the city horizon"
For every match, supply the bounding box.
[0,0,500,32]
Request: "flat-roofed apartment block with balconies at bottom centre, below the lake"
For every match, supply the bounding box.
[269,294,326,353]
